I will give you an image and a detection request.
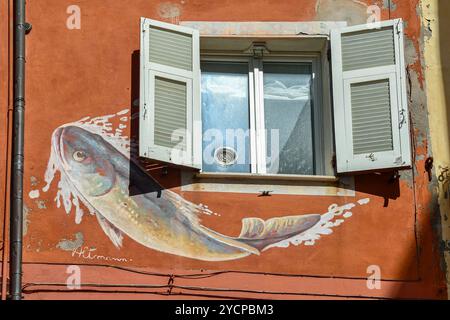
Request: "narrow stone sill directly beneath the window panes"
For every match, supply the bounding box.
[195,172,339,182]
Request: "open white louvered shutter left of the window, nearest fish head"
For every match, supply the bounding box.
[139,18,201,168]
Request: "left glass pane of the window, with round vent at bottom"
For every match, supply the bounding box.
[202,62,250,172]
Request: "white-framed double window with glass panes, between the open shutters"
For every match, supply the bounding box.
[201,57,323,175]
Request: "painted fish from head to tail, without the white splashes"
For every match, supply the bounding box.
[44,126,320,261]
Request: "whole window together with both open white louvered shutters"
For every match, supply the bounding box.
[139,18,411,176]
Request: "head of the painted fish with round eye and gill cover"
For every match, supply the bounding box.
[52,126,116,197]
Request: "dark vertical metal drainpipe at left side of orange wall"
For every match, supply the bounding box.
[9,0,31,300]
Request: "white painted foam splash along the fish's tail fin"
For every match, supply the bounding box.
[265,198,370,250]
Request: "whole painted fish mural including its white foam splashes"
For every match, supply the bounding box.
[37,110,369,261]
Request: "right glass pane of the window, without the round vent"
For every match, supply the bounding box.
[263,63,315,175]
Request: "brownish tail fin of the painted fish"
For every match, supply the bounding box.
[235,214,320,251]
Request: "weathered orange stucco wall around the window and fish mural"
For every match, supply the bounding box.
[0,0,447,299]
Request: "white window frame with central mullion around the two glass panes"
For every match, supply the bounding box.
[200,52,333,177]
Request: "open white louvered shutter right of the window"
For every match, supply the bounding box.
[331,19,411,173]
